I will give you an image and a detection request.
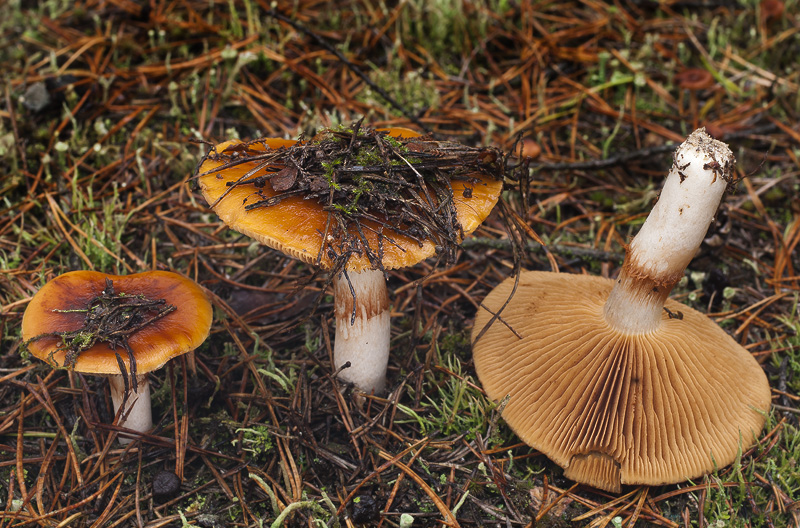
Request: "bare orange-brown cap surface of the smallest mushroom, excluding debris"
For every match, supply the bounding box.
[22,271,212,374]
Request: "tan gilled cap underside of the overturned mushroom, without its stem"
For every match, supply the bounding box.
[473,272,770,492]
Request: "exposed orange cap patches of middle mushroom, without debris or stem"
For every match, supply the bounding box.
[198,128,503,271]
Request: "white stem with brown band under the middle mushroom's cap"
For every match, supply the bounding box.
[333,270,390,394]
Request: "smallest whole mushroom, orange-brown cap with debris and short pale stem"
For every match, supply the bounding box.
[22,271,212,444]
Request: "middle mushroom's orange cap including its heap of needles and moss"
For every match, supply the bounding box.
[198,124,503,271]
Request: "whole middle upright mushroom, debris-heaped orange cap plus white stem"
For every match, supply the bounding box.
[198,125,502,393]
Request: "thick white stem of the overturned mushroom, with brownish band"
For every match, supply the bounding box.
[604,128,735,333]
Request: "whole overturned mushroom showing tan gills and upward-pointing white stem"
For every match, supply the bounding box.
[473,129,770,492]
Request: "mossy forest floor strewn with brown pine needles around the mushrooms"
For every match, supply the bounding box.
[0,0,800,528]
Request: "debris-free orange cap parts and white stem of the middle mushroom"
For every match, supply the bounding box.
[198,128,502,393]
